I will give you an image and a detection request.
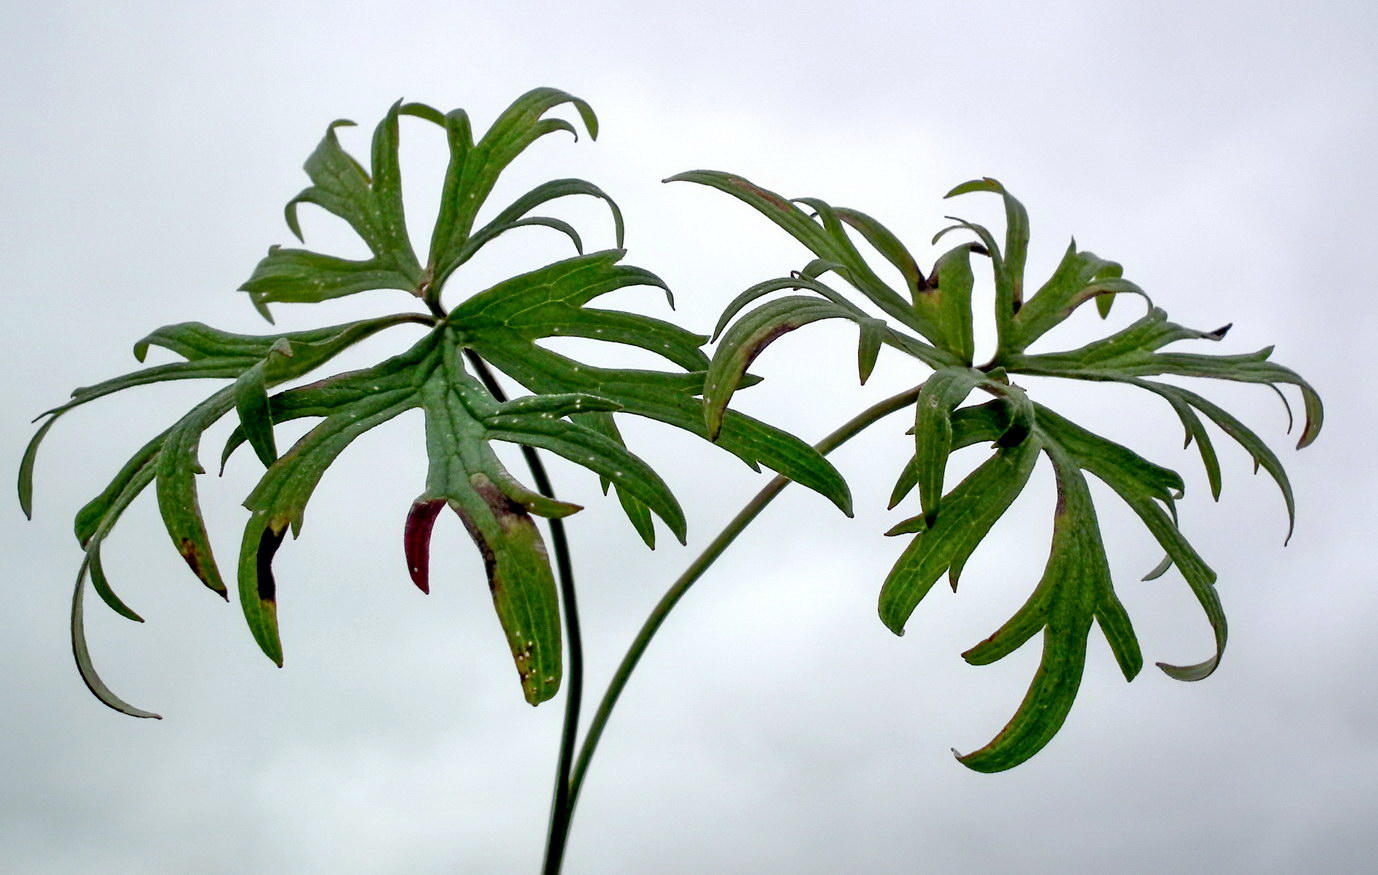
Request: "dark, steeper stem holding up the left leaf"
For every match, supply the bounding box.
[464,350,584,875]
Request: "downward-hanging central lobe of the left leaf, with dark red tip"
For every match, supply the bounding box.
[230,325,685,704]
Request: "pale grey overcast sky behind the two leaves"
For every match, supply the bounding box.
[0,0,1378,874]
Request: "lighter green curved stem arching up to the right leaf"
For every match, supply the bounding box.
[557,387,919,826]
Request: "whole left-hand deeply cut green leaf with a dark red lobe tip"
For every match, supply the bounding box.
[29,94,850,717]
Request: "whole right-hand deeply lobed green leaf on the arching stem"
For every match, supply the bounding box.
[700,171,1323,772]
